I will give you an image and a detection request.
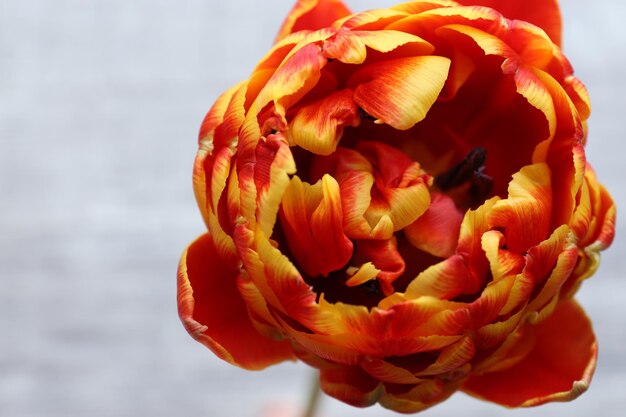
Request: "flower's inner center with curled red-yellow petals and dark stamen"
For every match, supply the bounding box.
[274,141,470,307]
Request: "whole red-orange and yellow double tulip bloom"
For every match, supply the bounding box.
[178,0,615,413]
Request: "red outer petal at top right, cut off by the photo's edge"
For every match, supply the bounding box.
[456,0,561,46]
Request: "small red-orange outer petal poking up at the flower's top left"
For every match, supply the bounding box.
[276,0,352,42]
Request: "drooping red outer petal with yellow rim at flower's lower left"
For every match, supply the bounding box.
[178,234,296,370]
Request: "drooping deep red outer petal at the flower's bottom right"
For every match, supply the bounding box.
[463,299,598,407]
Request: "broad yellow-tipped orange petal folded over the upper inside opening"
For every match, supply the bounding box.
[349,56,450,130]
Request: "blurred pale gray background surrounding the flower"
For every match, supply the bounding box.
[0,0,626,417]
